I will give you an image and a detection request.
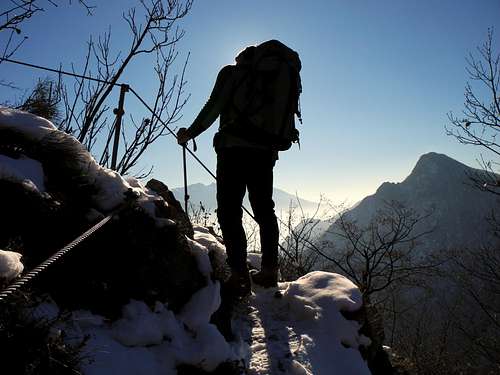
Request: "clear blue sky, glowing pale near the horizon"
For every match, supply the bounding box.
[0,0,500,203]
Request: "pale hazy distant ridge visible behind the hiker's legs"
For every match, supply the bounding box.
[172,183,317,215]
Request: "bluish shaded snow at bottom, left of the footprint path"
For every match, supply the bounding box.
[62,229,237,375]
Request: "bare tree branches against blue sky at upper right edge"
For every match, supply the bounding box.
[446,29,500,195]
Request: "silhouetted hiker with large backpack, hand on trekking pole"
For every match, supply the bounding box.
[177,40,301,296]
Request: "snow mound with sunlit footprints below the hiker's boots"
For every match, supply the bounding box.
[233,272,370,375]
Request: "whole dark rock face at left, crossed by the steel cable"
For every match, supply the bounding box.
[0,122,205,317]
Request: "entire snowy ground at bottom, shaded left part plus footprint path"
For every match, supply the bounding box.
[72,227,370,375]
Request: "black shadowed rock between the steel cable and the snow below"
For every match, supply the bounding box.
[36,197,205,318]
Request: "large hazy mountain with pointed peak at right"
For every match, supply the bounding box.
[321,152,499,252]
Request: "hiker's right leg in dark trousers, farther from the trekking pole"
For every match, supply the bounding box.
[247,151,279,279]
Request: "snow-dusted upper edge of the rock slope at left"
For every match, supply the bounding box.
[0,107,170,217]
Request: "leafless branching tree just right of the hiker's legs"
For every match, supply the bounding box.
[274,201,437,299]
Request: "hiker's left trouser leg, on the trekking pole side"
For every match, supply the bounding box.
[217,150,247,272]
